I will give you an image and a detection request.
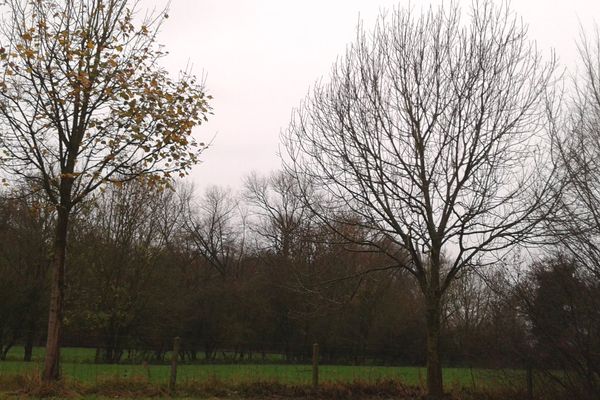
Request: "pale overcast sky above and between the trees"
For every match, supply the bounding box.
[141,0,600,190]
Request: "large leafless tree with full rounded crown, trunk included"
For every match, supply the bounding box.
[282,1,556,399]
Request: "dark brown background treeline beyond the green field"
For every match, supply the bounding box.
[0,173,600,378]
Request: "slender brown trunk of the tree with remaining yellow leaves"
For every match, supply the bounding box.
[42,206,69,382]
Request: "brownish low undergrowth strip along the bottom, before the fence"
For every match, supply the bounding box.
[0,374,547,400]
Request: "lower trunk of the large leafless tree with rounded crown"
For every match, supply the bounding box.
[427,295,444,400]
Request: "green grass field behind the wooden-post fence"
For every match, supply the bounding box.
[0,348,524,388]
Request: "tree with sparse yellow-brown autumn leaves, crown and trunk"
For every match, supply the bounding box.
[0,0,209,380]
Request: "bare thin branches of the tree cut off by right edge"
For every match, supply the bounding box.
[550,27,600,279]
